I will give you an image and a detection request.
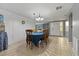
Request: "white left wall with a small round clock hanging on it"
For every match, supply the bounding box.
[0,9,34,44]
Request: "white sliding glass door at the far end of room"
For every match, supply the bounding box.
[49,21,65,36]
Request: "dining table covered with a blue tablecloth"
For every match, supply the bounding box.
[32,32,44,46]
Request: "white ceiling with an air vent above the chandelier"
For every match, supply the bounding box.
[0,3,73,22]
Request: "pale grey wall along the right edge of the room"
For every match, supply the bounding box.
[72,4,79,55]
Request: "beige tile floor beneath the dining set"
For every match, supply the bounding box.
[0,37,74,56]
